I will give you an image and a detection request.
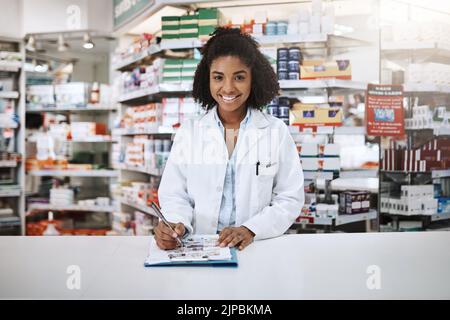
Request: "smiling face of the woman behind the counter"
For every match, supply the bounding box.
[209,56,252,113]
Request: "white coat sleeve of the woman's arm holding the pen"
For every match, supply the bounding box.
[158,124,193,234]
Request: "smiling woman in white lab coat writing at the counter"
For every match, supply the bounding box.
[155,28,304,250]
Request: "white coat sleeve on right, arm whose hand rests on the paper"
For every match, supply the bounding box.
[243,126,305,240]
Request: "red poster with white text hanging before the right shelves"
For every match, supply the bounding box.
[366,84,405,137]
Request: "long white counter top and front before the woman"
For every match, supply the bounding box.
[0,232,450,299]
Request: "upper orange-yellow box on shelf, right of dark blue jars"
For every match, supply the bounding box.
[300,60,352,80]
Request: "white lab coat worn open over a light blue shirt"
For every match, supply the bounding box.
[158,109,304,240]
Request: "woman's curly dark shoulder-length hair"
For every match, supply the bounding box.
[192,27,280,110]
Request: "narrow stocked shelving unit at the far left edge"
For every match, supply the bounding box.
[0,37,25,235]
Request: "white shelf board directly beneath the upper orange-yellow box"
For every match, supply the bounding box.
[279,79,367,90]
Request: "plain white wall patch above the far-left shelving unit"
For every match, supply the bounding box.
[0,0,23,38]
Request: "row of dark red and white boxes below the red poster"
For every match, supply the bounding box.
[381,137,450,172]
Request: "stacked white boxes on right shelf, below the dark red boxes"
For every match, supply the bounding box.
[381,185,438,216]
